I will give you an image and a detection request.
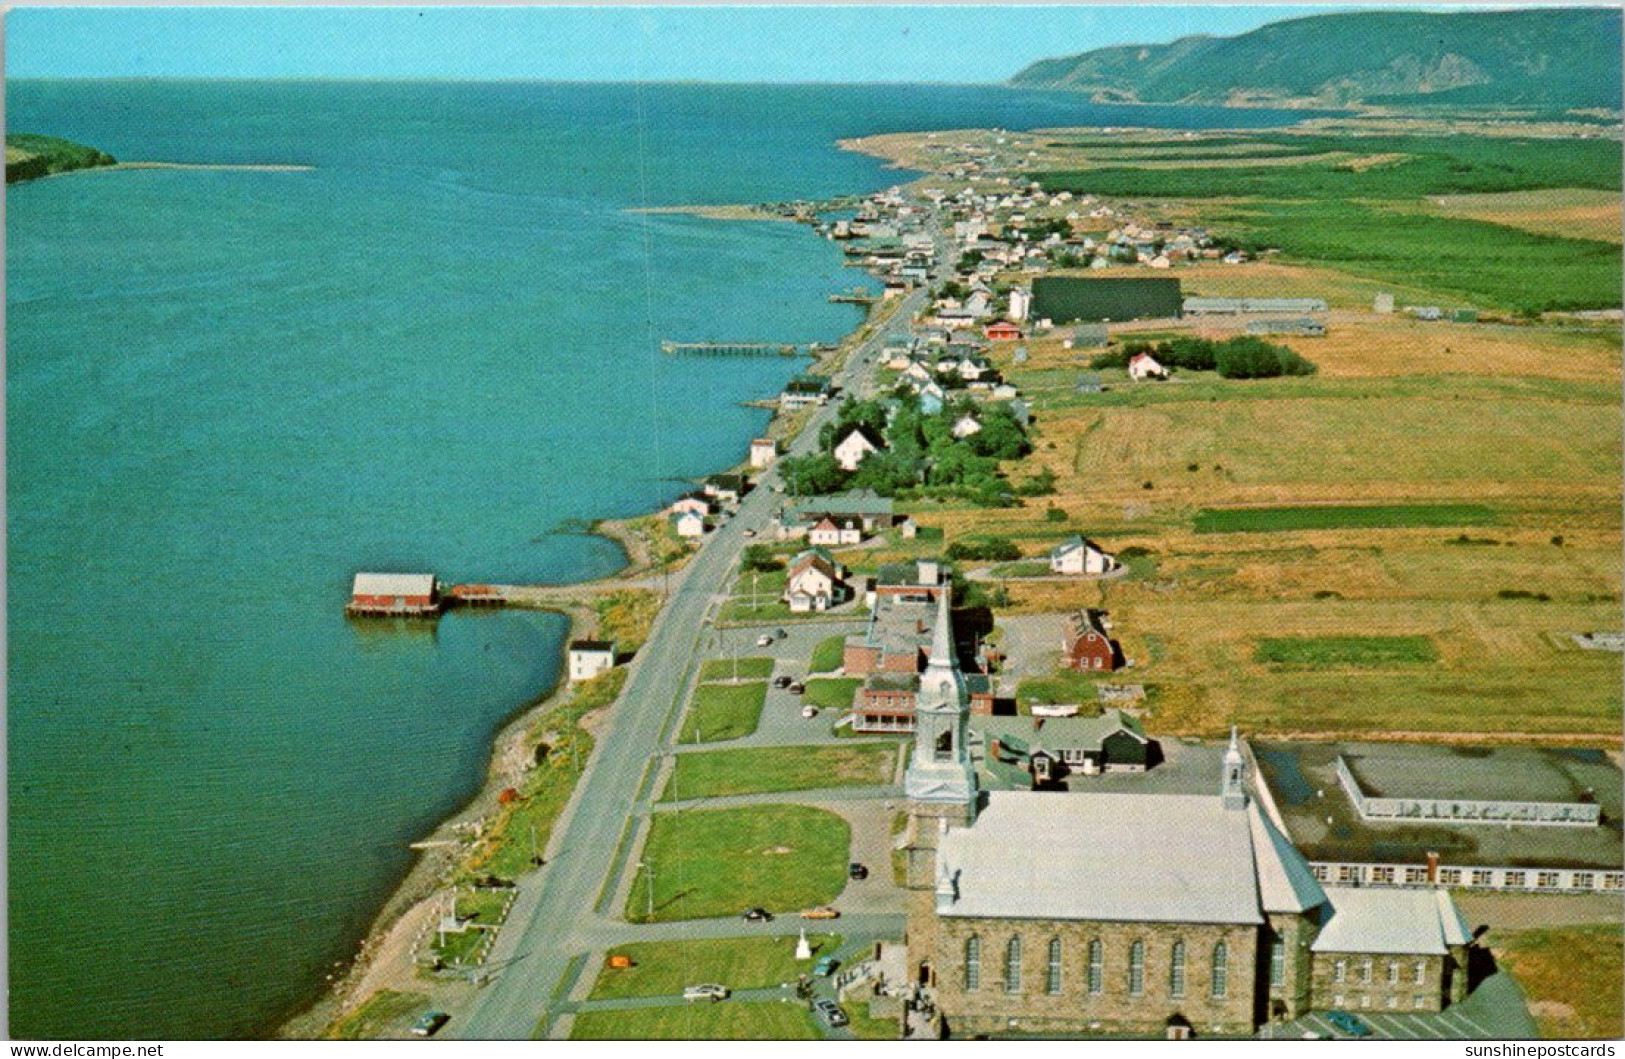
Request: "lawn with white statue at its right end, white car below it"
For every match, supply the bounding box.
[590,934,840,1001]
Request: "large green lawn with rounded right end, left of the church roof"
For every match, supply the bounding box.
[627,806,852,923]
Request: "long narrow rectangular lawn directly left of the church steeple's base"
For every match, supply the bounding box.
[661,742,897,801]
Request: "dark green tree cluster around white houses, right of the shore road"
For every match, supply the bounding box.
[778,390,1042,507]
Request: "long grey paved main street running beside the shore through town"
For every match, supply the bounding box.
[449,277,926,1040]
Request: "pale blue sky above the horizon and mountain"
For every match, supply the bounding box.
[5,5,1349,83]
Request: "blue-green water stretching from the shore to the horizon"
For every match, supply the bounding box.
[7,81,1313,1038]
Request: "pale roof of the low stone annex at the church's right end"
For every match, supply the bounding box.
[1311,887,1472,957]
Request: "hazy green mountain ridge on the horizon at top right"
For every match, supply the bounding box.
[1009,8,1620,110]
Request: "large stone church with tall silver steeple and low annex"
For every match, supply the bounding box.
[905,593,1472,1036]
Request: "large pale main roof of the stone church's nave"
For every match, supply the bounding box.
[938,791,1280,924]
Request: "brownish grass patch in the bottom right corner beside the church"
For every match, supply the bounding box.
[1492,924,1625,1040]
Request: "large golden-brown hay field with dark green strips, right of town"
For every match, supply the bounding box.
[918,312,1625,746]
